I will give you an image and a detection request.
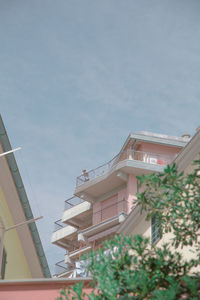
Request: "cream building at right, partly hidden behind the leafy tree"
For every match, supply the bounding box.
[117,127,200,273]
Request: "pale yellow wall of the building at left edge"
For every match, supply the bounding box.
[0,187,32,279]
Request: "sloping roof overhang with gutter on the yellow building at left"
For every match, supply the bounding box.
[0,116,51,277]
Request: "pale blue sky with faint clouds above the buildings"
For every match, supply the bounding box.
[0,0,200,270]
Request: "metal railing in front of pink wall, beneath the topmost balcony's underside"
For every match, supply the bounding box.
[94,199,128,224]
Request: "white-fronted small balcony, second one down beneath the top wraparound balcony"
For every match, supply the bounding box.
[51,219,79,251]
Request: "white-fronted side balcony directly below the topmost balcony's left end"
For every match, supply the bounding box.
[62,196,92,229]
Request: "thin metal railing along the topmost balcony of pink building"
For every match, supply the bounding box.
[76,149,175,186]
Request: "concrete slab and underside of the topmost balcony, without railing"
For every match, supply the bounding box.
[75,160,164,202]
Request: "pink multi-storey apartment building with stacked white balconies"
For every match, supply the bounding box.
[51,132,189,277]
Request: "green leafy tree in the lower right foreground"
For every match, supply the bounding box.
[59,161,200,300]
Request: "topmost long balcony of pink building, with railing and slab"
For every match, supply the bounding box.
[75,149,175,202]
